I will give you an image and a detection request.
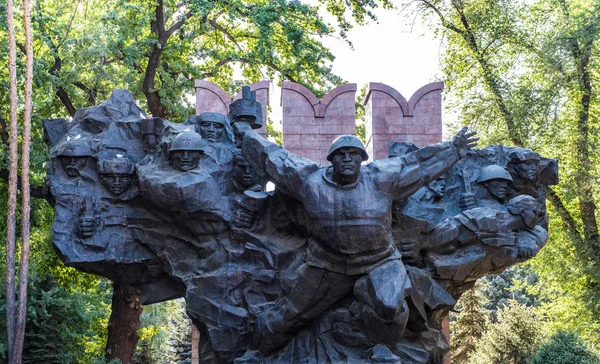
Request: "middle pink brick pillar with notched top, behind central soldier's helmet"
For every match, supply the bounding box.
[281,82,356,164]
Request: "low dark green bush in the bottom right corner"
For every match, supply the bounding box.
[527,331,600,364]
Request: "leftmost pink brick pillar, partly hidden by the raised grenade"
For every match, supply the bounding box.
[195,80,271,136]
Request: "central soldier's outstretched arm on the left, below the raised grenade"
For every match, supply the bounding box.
[233,122,319,200]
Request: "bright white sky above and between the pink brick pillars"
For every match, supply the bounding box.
[270,4,450,128]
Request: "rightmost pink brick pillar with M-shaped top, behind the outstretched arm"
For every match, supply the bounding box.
[365,82,444,160]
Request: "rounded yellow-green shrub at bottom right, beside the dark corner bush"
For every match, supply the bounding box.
[468,300,542,364]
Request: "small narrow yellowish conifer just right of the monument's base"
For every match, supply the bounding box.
[450,288,486,363]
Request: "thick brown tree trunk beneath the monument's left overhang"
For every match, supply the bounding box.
[105,282,143,364]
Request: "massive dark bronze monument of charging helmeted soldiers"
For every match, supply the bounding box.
[44,88,558,363]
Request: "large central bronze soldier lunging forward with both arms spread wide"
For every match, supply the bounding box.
[234,120,476,353]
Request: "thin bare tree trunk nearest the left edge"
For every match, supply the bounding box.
[6,0,18,363]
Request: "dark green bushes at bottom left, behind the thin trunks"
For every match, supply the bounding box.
[0,273,110,363]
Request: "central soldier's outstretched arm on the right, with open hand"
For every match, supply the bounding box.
[370,127,479,200]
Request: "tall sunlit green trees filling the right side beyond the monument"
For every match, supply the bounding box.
[416,0,600,345]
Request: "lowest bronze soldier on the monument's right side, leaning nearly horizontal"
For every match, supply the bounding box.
[425,195,548,284]
